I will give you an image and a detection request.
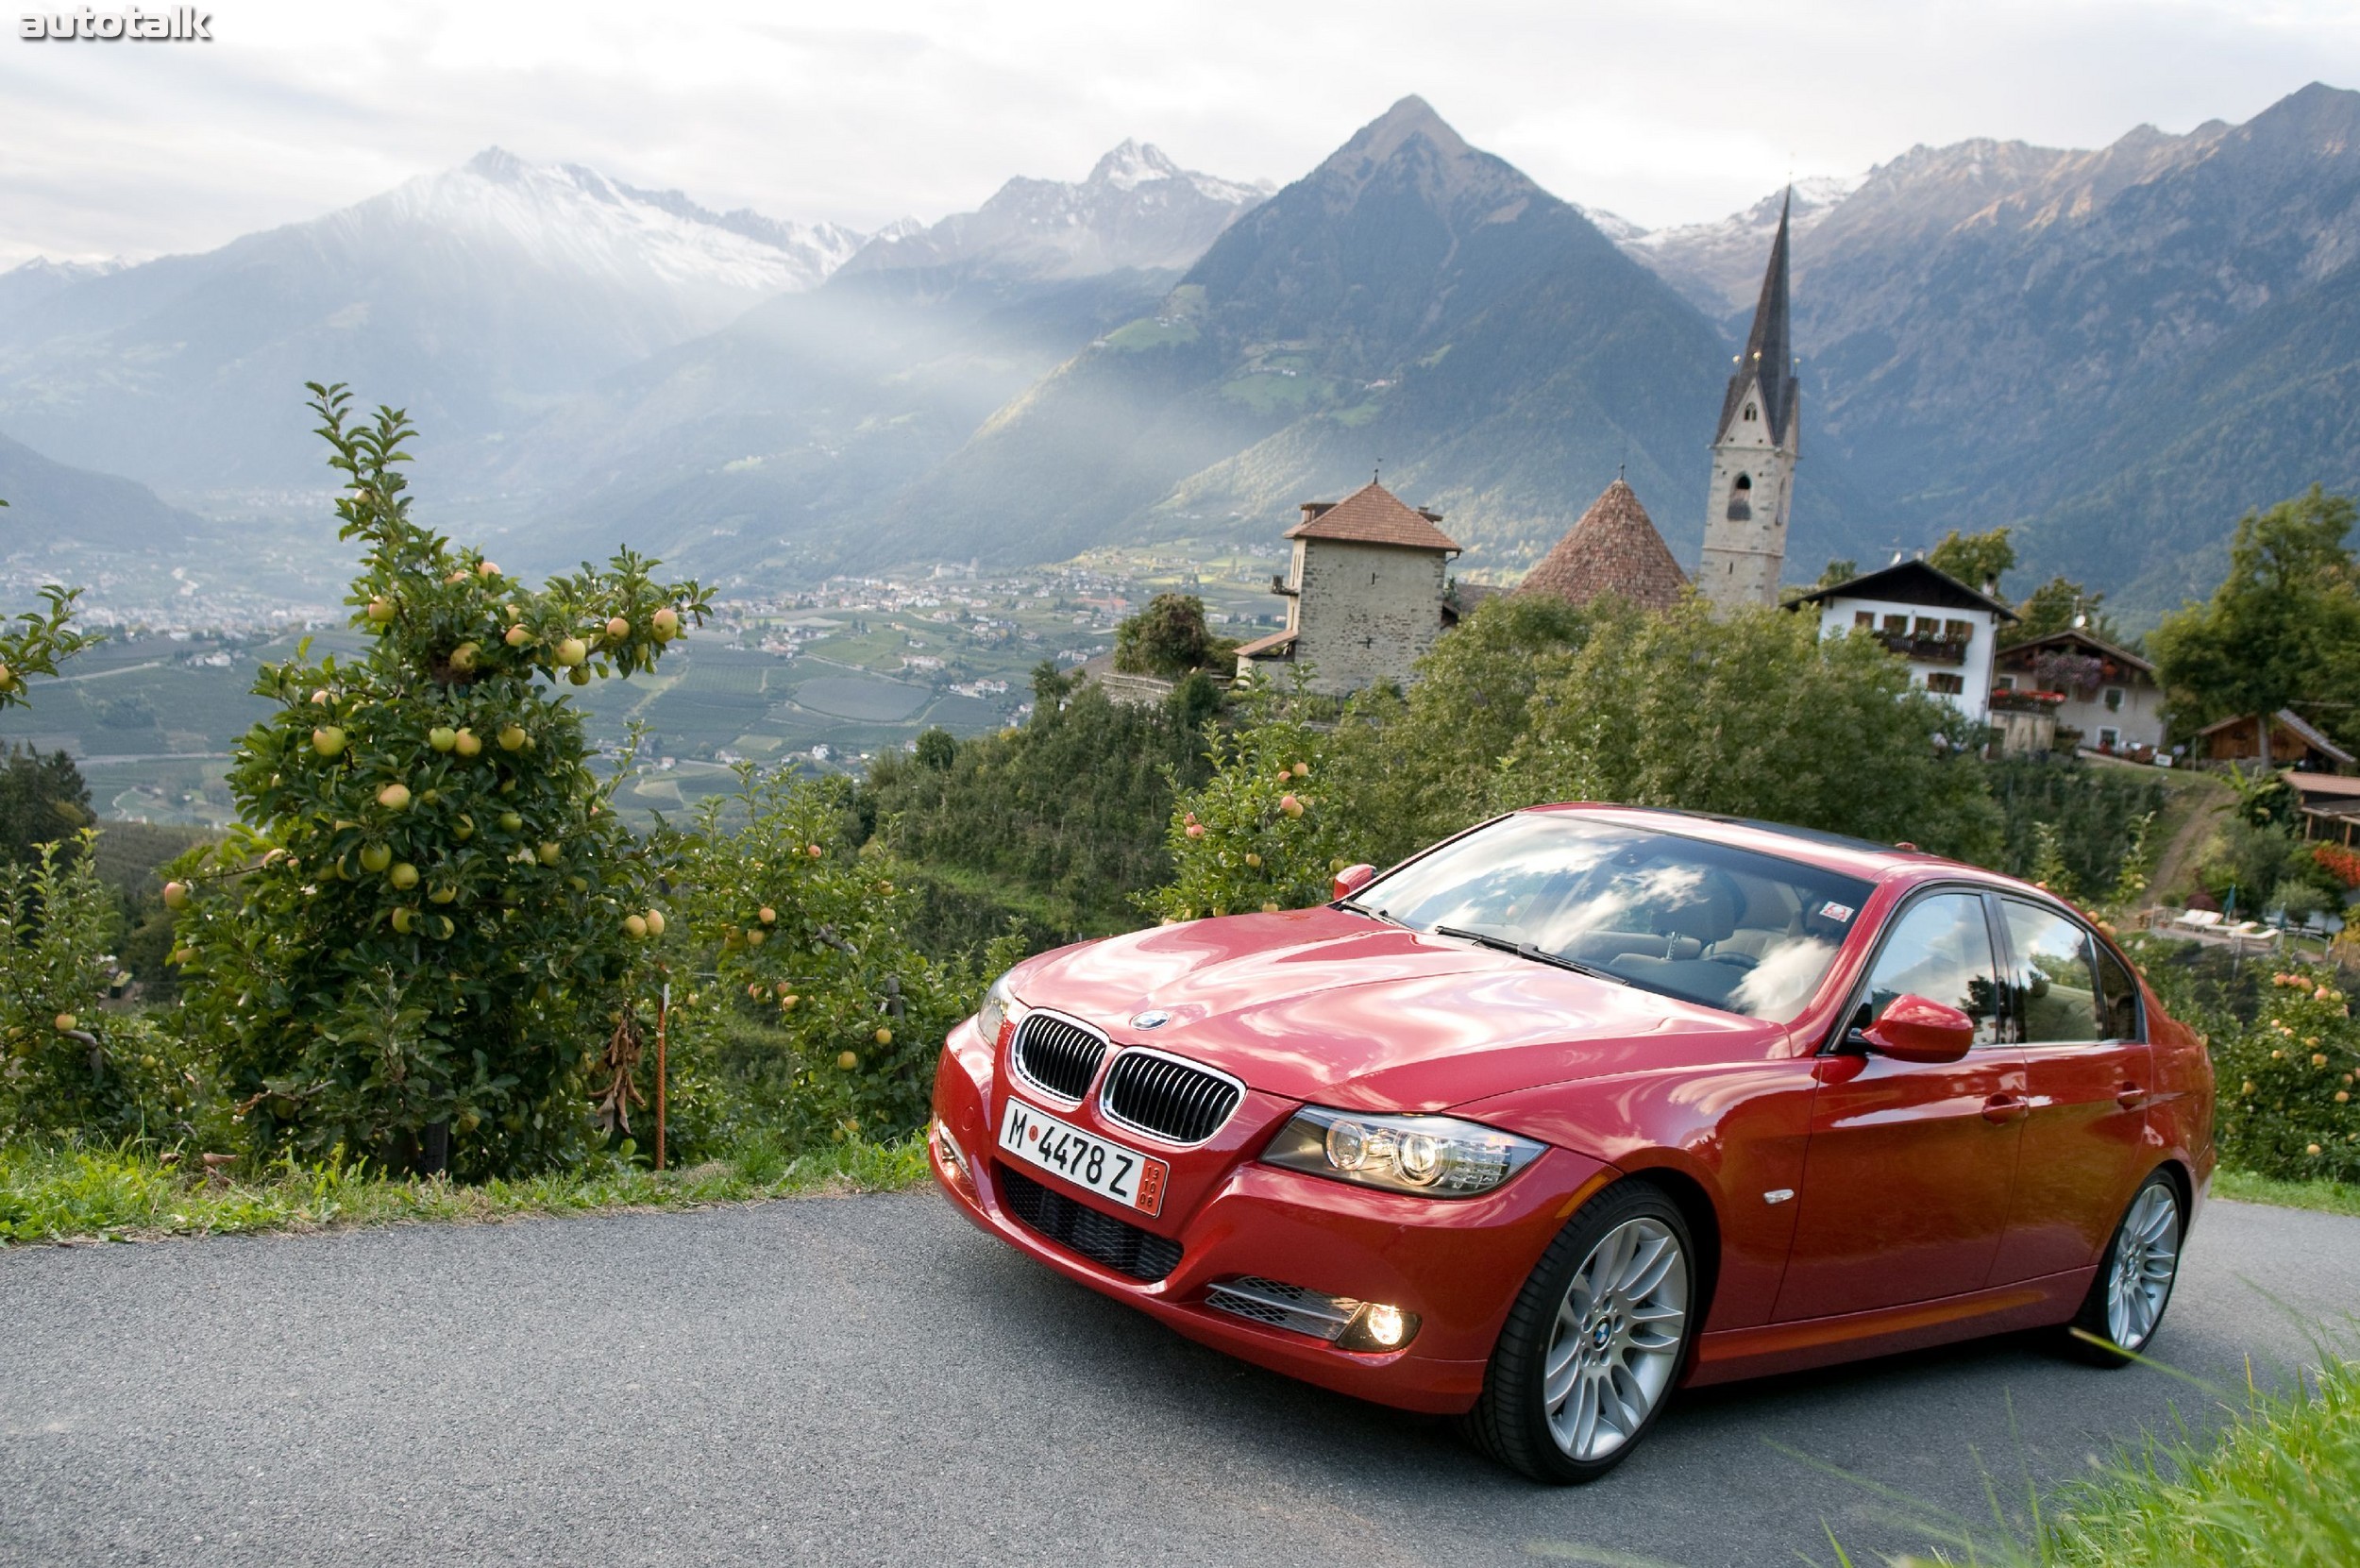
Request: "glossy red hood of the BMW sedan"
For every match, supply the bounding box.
[1013,907,1787,1110]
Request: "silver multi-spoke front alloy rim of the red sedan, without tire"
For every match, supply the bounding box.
[1542,1214,1690,1459]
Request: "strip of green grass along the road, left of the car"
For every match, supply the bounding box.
[0,1136,928,1247]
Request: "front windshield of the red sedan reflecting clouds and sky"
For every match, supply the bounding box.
[1350,813,1869,1022]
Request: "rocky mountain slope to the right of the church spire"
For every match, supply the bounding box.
[1624,85,2360,616]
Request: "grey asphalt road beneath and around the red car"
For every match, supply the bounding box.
[0,1192,2360,1568]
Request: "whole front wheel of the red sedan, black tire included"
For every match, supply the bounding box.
[1463,1181,1704,1485]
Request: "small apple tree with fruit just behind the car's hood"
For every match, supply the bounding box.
[1140,684,1348,921]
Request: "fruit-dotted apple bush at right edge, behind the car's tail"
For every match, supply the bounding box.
[2212,966,2360,1181]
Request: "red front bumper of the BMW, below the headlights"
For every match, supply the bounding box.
[930,1020,1608,1414]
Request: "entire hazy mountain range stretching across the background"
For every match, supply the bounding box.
[0,85,2360,618]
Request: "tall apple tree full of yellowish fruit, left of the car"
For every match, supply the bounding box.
[165,382,708,1176]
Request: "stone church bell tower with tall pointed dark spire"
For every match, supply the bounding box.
[1697,192,1803,609]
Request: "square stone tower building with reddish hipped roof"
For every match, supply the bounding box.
[1237,481,1458,697]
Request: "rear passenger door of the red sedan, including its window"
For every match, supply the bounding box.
[1992,898,2155,1285]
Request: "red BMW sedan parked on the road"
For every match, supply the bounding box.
[933,805,2214,1483]
